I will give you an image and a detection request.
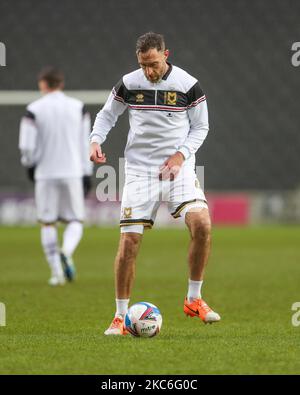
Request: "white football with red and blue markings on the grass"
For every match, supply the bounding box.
[125,302,162,337]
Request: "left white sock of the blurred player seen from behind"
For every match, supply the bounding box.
[41,226,63,277]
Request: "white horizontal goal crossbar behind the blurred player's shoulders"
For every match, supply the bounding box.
[0,90,110,106]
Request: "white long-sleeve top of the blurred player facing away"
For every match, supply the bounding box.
[19,91,93,180]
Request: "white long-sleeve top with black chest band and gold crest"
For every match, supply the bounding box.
[91,64,209,170]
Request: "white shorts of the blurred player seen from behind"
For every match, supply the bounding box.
[35,178,84,224]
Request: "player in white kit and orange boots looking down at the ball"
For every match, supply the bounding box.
[91,32,220,335]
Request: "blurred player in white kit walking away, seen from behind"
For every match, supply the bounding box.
[19,67,93,286]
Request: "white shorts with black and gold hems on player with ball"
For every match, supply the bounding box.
[120,167,208,233]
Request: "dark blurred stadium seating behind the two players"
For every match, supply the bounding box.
[0,0,300,226]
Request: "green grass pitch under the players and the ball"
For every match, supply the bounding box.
[0,227,300,374]
